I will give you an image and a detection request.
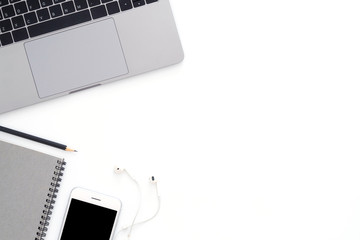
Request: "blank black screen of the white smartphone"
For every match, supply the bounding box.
[61,199,117,240]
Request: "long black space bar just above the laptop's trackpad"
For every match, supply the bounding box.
[28,10,91,37]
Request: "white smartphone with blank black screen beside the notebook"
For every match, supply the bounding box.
[59,188,121,240]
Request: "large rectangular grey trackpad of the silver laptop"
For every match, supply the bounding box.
[25,19,128,98]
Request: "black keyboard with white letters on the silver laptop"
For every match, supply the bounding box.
[0,0,158,48]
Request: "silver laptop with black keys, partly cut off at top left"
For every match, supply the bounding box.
[0,0,183,113]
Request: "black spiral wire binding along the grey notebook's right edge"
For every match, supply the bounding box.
[35,160,66,240]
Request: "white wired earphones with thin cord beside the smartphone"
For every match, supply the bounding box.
[114,166,160,239]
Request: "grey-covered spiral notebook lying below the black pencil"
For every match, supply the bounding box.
[0,141,65,240]
